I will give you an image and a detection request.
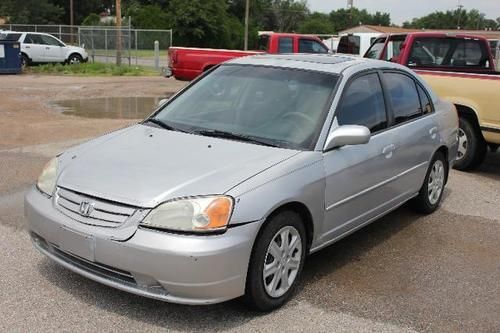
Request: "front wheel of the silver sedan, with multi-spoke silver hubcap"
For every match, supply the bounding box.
[244,211,306,311]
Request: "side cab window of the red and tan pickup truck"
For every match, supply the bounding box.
[408,37,489,68]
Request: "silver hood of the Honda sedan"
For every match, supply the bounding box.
[57,125,300,208]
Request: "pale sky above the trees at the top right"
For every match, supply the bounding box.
[307,0,500,24]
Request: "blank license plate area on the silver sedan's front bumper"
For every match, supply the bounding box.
[57,227,95,261]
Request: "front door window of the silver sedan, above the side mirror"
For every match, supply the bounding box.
[336,73,387,133]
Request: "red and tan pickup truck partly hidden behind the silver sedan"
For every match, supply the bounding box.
[365,32,500,170]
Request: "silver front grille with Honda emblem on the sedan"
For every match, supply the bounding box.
[56,187,136,228]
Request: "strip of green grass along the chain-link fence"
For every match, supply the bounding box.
[25,62,159,76]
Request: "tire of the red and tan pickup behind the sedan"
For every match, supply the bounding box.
[453,117,487,171]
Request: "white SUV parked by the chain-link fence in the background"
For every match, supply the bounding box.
[0,31,89,67]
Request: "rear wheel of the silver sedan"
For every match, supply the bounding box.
[413,151,448,214]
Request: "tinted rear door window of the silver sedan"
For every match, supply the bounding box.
[384,73,423,125]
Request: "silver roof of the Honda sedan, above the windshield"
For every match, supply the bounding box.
[228,54,407,74]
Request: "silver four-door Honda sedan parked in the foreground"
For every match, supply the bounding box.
[25,55,458,311]
